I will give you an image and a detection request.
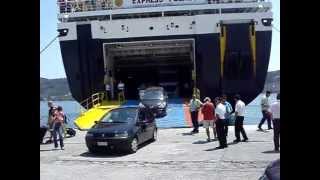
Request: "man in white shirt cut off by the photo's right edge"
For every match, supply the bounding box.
[270,93,280,151]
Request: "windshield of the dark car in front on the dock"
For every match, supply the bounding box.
[100,108,137,123]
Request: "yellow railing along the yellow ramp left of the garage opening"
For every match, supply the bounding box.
[79,92,105,114]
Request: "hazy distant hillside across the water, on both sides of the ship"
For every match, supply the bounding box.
[40,70,280,100]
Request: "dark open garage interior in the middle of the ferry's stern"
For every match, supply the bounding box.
[104,39,195,99]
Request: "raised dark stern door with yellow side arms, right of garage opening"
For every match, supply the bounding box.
[220,22,256,80]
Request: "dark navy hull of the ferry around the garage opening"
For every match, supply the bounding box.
[60,25,272,104]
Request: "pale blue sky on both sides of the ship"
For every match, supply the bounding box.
[39,0,280,79]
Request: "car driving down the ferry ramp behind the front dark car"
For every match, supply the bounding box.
[139,87,168,118]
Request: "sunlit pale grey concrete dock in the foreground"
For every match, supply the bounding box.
[40,125,280,180]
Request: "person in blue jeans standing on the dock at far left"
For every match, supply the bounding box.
[53,106,64,150]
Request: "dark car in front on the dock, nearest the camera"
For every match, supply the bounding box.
[86,107,157,153]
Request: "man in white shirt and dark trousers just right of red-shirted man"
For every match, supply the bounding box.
[215,97,228,149]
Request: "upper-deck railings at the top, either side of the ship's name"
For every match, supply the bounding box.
[57,0,270,14]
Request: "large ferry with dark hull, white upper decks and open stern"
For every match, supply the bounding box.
[58,0,272,104]
